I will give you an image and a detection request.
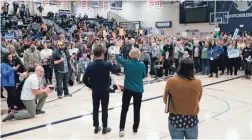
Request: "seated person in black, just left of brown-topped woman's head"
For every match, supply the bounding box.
[162,52,176,77]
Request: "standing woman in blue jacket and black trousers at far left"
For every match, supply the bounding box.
[1,53,18,112]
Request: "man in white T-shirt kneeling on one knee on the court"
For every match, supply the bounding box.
[2,66,52,122]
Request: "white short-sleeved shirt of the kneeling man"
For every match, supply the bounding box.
[21,73,39,100]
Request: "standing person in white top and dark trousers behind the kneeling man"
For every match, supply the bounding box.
[40,43,53,84]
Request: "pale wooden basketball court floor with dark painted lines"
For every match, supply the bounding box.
[1,74,252,140]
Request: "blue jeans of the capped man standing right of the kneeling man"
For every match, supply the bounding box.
[55,72,69,96]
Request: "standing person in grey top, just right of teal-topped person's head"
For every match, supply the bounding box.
[139,40,151,77]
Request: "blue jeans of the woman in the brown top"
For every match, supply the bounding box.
[169,123,198,139]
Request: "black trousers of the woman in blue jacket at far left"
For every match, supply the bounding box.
[4,86,16,110]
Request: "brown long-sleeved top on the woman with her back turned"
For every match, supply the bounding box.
[163,77,202,115]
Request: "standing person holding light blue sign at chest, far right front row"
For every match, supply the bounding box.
[227,40,240,77]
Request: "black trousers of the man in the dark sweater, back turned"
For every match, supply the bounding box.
[92,91,109,128]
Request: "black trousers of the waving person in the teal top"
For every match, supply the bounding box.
[120,89,142,130]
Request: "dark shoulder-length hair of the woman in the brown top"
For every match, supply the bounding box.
[177,57,195,80]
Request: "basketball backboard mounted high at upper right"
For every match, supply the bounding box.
[209,12,229,25]
